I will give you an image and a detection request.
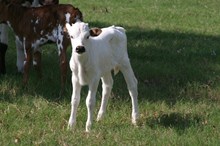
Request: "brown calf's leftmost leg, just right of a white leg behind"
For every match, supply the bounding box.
[23,41,33,85]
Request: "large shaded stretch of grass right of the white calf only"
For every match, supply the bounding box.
[128,28,220,105]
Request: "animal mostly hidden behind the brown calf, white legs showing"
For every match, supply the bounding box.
[0,0,59,74]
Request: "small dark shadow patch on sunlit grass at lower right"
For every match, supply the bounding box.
[146,112,202,135]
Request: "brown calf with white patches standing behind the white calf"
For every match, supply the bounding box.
[0,0,82,89]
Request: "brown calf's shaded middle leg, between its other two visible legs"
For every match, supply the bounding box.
[33,49,42,78]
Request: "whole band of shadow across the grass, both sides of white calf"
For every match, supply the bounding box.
[1,22,220,105]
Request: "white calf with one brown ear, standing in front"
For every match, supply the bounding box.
[66,21,138,132]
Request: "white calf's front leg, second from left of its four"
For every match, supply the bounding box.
[86,78,99,132]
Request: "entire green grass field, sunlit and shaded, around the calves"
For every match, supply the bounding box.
[0,0,220,146]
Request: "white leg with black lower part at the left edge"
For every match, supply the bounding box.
[0,24,8,74]
